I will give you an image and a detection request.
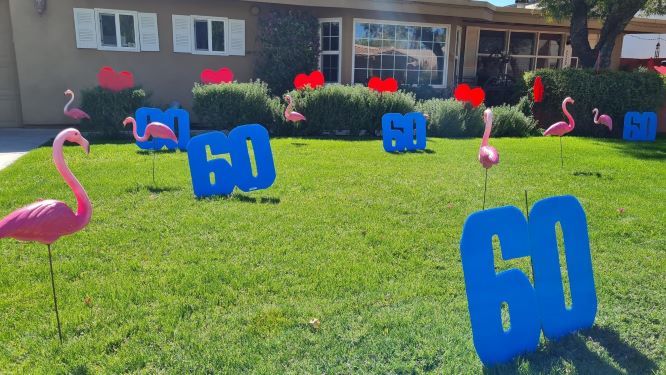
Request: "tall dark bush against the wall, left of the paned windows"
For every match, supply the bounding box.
[256,10,319,94]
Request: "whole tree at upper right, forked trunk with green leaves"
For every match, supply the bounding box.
[539,0,666,68]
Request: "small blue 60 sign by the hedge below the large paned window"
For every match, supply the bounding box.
[382,112,426,152]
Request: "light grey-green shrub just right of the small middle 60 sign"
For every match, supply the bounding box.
[417,99,485,138]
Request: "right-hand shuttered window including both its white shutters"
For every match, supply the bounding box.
[171,14,245,56]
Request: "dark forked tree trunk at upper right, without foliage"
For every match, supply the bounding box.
[571,0,647,69]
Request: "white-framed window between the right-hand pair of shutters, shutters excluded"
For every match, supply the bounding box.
[192,16,227,55]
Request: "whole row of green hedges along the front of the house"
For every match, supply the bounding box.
[82,69,666,137]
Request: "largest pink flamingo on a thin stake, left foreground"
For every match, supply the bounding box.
[0,129,92,343]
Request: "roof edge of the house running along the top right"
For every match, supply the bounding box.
[248,0,666,34]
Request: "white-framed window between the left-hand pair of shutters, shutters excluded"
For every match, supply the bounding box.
[95,9,139,51]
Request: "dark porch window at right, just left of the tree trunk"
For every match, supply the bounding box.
[477,30,577,85]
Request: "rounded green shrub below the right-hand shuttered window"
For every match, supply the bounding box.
[192,81,278,131]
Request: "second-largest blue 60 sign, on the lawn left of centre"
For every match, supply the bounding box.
[187,124,276,198]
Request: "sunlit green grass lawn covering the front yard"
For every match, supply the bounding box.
[0,137,666,374]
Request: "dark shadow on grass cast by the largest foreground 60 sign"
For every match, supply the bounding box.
[483,326,657,375]
